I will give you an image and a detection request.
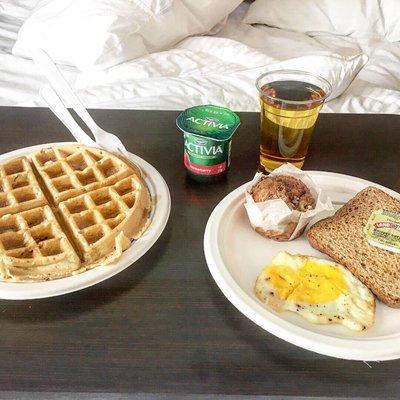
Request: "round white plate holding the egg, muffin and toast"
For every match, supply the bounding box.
[204,171,400,361]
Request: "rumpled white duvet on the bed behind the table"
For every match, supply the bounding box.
[0,0,400,113]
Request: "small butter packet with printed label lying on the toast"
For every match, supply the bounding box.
[364,209,400,253]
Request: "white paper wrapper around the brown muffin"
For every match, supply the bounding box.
[244,164,334,240]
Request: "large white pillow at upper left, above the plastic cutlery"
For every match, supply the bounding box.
[13,0,241,70]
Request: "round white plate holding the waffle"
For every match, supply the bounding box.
[0,142,171,300]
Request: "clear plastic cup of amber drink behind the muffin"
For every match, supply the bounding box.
[256,70,332,172]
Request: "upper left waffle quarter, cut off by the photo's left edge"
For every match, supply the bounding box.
[0,157,47,217]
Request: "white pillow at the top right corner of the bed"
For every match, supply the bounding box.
[243,0,400,41]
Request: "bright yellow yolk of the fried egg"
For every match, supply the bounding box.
[266,261,347,304]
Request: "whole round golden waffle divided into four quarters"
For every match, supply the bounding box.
[0,145,151,282]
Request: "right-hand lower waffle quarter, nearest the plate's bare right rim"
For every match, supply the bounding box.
[60,175,150,265]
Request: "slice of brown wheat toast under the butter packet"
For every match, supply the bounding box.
[307,186,400,307]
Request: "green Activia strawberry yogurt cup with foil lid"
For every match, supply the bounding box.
[176,104,240,182]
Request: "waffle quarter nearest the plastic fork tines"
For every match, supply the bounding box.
[32,146,133,204]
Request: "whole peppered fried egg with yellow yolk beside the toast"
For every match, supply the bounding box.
[255,251,375,331]
